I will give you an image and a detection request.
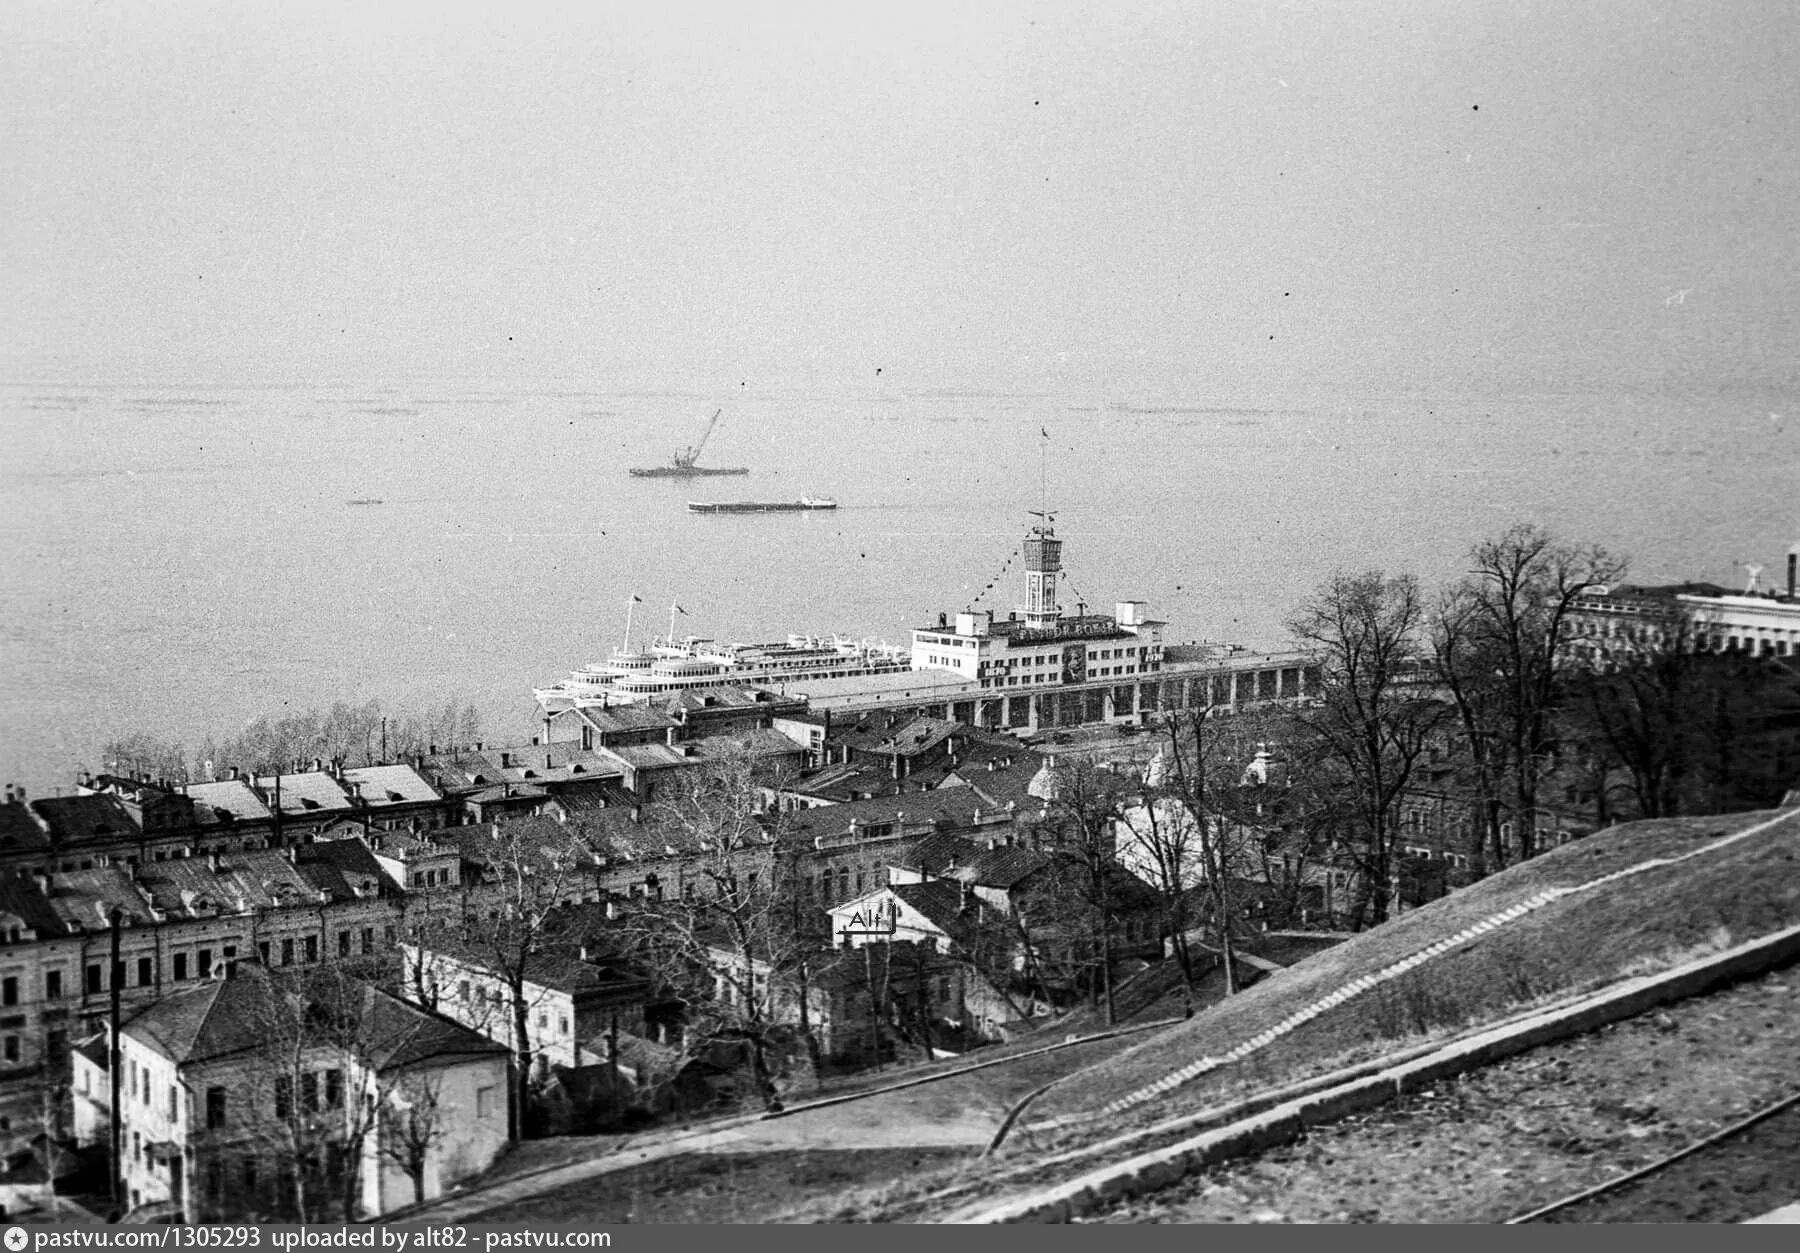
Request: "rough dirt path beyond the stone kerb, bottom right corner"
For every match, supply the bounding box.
[1100,969,1800,1222]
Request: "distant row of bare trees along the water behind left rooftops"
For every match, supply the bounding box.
[101,700,482,783]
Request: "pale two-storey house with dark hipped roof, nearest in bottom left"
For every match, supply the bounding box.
[107,967,508,1222]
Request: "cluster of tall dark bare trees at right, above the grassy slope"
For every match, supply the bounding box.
[1280,526,1800,925]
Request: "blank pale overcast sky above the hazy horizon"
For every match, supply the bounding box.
[0,0,1800,391]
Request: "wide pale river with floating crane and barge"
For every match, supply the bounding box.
[0,382,1800,796]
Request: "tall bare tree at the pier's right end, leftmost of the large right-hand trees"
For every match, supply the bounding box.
[1287,571,1444,927]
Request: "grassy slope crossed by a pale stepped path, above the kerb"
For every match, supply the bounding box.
[1031,810,1800,1131]
